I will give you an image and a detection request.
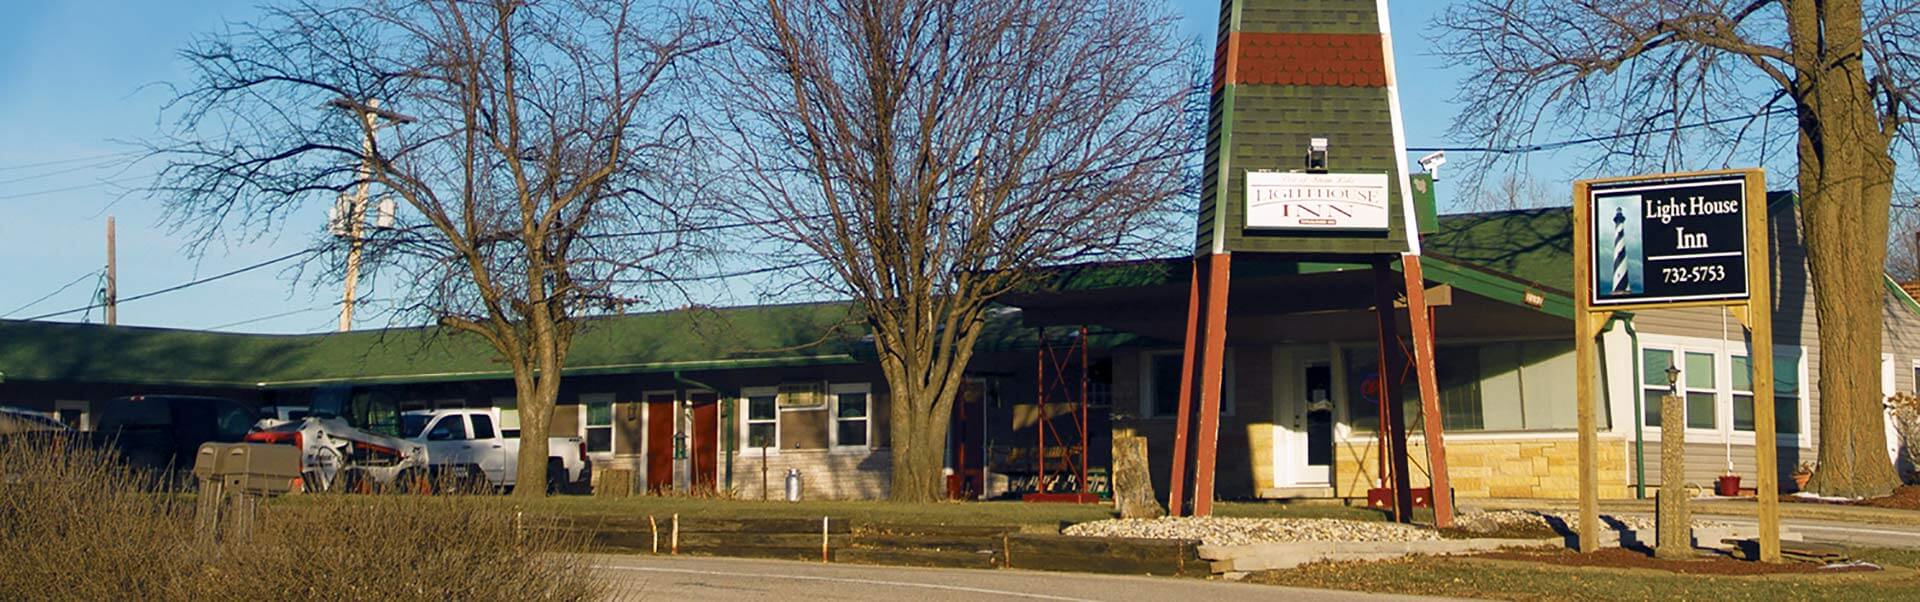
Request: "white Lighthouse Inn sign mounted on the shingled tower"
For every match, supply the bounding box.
[1246,171,1390,230]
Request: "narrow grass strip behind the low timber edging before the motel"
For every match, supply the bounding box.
[263,497,1384,527]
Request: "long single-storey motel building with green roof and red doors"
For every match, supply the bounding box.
[0,196,1920,500]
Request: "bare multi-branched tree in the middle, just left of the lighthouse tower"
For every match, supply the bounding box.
[714,0,1190,500]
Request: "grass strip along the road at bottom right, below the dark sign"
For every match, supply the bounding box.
[1248,548,1920,600]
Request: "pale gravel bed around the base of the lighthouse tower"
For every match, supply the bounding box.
[1064,518,1440,546]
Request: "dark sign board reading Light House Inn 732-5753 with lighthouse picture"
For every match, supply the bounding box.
[1582,174,1759,307]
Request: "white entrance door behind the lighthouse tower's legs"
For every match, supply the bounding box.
[1273,349,1334,487]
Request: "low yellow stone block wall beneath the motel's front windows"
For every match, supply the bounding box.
[1334,437,1632,498]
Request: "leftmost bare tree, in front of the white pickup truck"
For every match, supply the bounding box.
[152,0,714,495]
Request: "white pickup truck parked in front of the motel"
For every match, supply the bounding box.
[399,408,593,493]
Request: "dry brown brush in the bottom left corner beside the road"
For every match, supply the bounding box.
[0,439,607,600]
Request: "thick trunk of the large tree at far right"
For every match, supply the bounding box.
[1793,8,1899,498]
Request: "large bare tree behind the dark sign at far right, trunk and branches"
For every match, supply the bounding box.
[1438,0,1920,497]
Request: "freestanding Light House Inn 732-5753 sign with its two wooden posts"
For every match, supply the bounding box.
[1572,169,1780,562]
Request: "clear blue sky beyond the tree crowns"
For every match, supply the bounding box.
[0,0,1528,332]
